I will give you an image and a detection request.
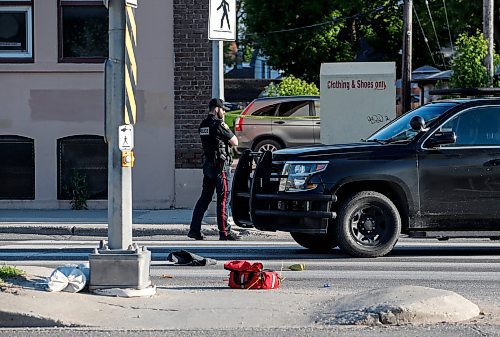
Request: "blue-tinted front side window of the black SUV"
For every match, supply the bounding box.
[441,107,500,147]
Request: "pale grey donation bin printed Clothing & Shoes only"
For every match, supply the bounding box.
[321,62,396,144]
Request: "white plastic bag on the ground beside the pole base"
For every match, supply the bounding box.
[47,264,88,293]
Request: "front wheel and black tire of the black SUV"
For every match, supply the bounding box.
[336,191,401,257]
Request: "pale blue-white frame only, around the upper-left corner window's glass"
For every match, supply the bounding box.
[0,0,35,63]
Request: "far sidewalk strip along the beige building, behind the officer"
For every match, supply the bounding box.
[0,209,224,236]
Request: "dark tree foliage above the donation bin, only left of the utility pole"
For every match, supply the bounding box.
[244,0,402,82]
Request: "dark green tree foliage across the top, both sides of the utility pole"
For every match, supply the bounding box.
[243,0,500,82]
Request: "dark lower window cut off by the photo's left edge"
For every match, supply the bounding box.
[0,136,35,200]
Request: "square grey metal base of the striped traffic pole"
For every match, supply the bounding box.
[89,244,151,291]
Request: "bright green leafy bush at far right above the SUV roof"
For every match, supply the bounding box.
[450,31,492,88]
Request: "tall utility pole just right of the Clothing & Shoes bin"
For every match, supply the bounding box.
[401,0,413,113]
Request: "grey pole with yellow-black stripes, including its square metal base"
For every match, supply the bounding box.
[89,0,151,291]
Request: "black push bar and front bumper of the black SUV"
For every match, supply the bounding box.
[231,151,337,230]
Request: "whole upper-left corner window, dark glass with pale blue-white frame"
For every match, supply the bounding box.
[0,0,33,62]
